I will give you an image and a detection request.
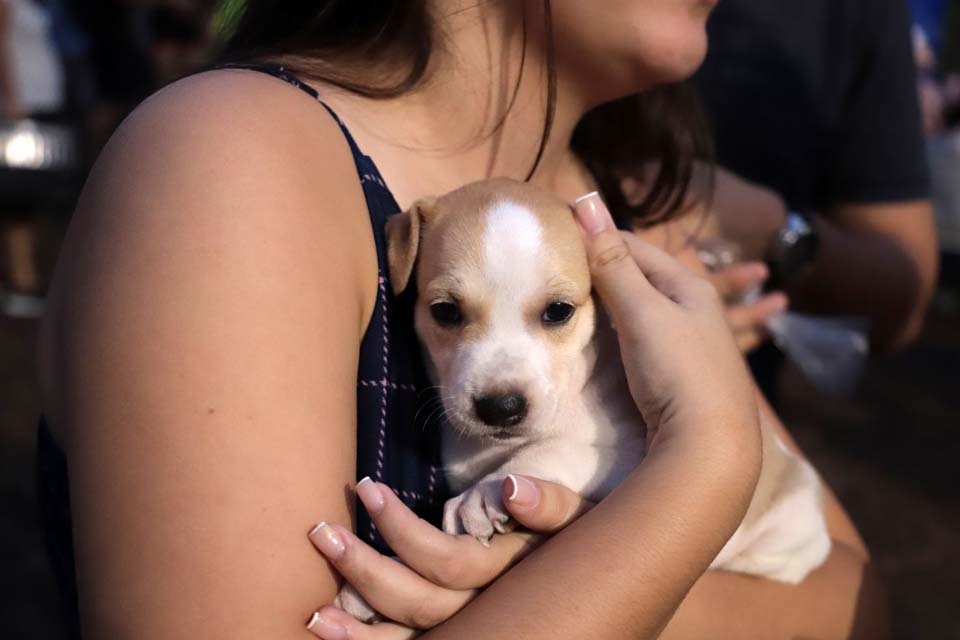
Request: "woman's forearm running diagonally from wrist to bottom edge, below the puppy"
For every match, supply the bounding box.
[425,434,759,640]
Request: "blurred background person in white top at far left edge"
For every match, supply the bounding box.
[0,0,65,318]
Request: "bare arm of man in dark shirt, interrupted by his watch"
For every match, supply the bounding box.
[704,169,938,351]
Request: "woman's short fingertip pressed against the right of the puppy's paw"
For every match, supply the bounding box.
[503,475,593,533]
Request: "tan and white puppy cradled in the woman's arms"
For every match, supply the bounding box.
[387,179,830,583]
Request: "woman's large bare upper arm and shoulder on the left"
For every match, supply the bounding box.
[48,72,376,640]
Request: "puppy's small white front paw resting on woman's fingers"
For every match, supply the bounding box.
[443,478,516,545]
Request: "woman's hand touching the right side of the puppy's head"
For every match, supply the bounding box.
[575,194,759,444]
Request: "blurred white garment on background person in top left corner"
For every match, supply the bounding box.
[6,0,65,113]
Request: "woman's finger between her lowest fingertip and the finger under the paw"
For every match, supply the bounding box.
[310,523,476,629]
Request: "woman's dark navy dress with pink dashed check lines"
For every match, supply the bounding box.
[37,65,447,633]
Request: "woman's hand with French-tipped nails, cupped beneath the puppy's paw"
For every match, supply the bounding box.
[308,476,592,640]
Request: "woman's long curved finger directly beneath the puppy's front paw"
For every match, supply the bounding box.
[348,478,539,592]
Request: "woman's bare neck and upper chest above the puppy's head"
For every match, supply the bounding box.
[316,3,592,206]
